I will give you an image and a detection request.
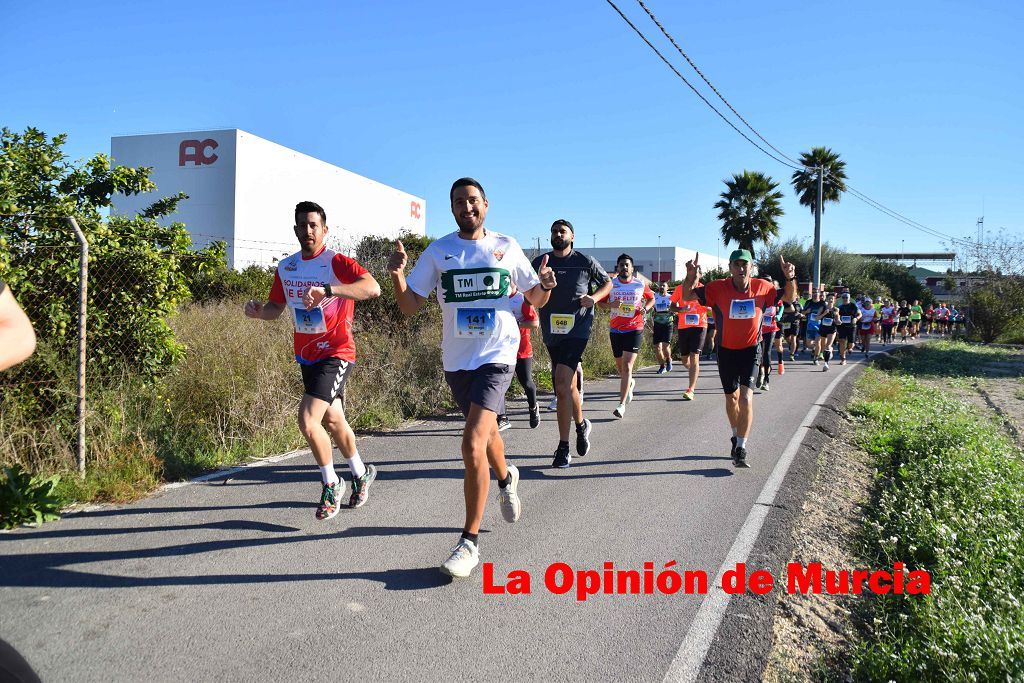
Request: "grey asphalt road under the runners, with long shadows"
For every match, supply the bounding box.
[0,344,892,681]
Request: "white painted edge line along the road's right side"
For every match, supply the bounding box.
[664,351,872,683]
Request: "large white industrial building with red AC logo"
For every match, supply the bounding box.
[111,128,427,268]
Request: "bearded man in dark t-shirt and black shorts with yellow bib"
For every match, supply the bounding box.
[534,218,611,469]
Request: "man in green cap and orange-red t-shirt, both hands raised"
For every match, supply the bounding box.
[680,249,797,467]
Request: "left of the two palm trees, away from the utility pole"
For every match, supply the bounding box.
[715,171,783,260]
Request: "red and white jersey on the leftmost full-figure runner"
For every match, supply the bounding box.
[268,247,367,366]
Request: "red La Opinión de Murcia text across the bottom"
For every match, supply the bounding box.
[483,560,932,602]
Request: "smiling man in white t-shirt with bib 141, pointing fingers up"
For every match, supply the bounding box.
[388,178,556,578]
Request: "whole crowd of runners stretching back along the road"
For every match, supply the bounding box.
[239,178,963,577]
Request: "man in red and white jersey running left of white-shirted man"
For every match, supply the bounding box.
[244,202,381,520]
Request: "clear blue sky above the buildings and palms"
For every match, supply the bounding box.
[0,0,1024,262]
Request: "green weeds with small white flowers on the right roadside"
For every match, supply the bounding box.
[851,344,1024,681]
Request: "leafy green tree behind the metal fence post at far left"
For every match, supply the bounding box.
[0,128,224,383]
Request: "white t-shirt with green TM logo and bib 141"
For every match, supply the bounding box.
[407,230,541,372]
